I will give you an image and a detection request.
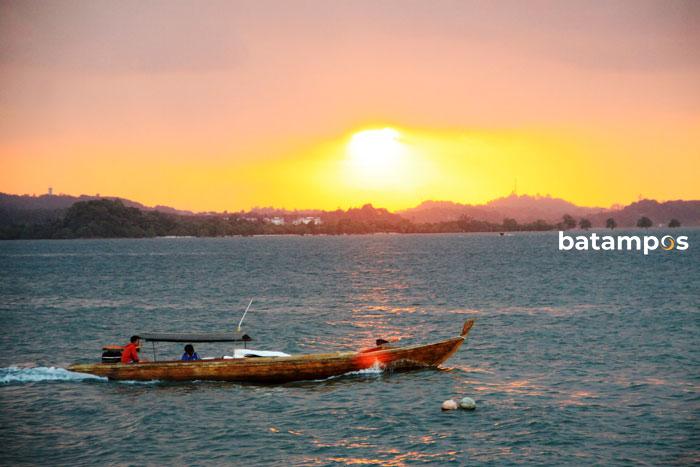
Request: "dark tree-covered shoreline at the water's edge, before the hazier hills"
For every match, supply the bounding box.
[0,199,680,240]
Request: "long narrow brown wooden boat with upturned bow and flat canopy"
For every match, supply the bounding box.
[68,319,474,383]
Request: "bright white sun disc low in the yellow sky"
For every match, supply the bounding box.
[347,128,405,176]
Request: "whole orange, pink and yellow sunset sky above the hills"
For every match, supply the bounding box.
[0,0,700,211]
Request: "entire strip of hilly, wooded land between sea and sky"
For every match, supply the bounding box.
[0,193,700,240]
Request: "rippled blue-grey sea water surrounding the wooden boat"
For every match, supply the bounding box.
[0,229,700,466]
